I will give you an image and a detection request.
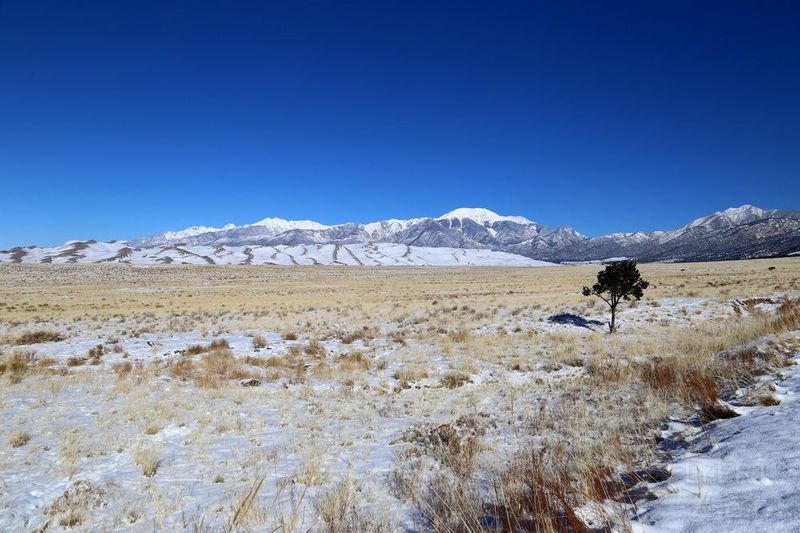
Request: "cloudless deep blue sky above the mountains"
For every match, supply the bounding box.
[0,0,800,247]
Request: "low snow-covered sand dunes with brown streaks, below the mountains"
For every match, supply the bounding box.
[0,241,552,266]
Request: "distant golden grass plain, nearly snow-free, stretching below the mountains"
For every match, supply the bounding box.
[0,258,800,330]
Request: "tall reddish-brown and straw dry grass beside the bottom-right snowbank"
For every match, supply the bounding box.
[393,301,800,532]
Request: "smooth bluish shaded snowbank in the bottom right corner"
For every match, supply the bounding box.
[633,356,800,533]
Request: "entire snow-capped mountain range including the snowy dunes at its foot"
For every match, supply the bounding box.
[0,205,800,266]
